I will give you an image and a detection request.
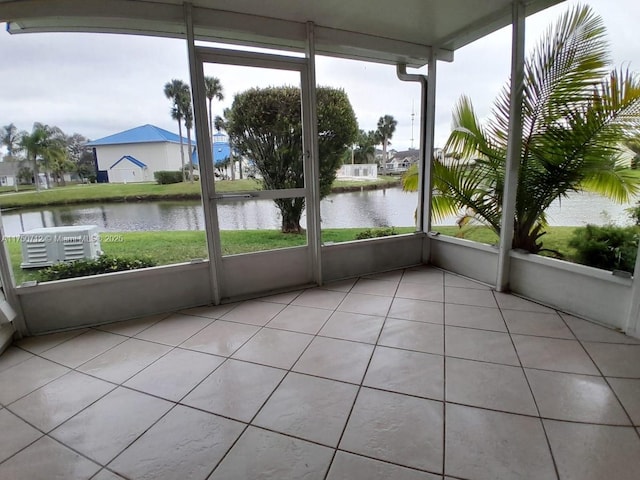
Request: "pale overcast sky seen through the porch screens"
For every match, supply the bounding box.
[0,0,640,149]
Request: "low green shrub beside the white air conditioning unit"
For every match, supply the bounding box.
[38,255,156,282]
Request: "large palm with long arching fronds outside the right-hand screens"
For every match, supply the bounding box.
[404,6,640,253]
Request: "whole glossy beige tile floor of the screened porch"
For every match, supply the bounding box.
[0,267,640,480]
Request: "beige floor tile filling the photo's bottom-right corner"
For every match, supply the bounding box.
[544,420,640,480]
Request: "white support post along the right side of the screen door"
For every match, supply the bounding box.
[302,22,322,285]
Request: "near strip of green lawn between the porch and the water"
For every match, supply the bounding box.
[7,227,575,285]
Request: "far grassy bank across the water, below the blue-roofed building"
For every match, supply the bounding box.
[0,176,400,209]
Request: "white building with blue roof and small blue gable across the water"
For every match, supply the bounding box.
[87,124,195,183]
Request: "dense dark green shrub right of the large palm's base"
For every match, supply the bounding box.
[569,225,638,273]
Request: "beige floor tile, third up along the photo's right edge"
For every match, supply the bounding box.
[584,342,640,378]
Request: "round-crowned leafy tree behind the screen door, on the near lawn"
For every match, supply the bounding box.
[225,87,358,233]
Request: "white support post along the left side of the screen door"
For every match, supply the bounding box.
[184,3,222,305]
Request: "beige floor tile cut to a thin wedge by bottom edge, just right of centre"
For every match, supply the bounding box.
[327,451,441,480]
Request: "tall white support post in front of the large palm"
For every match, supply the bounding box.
[496,0,525,292]
